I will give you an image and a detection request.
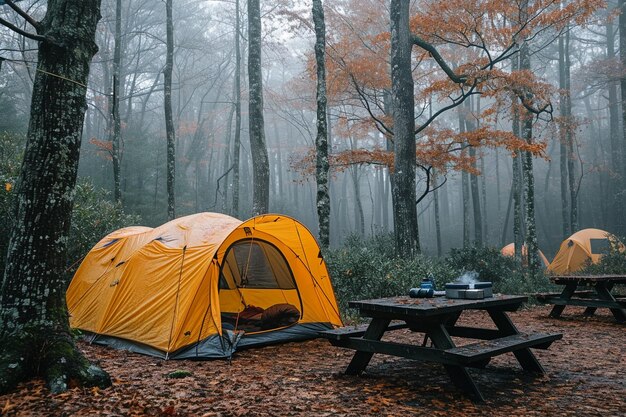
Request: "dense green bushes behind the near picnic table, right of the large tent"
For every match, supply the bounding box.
[326,235,554,320]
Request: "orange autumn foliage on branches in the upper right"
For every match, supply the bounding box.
[294,0,604,180]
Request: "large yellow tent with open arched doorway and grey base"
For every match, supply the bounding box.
[66,213,342,358]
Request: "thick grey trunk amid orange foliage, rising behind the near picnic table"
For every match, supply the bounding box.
[389,0,420,257]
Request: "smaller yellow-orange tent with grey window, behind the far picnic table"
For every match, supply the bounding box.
[548,229,614,274]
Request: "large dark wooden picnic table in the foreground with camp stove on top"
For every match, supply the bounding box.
[320,295,562,401]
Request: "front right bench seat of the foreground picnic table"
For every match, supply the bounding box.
[446,333,563,364]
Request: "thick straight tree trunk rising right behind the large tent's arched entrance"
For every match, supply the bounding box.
[248,0,270,215]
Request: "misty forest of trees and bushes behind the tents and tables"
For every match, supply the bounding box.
[0,0,626,415]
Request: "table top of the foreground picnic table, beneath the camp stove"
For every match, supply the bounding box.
[348,295,528,316]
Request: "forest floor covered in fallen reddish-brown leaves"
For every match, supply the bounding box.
[0,307,626,417]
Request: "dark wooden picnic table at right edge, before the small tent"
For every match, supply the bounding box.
[537,275,626,323]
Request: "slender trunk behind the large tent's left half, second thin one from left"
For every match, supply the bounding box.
[163,0,176,220]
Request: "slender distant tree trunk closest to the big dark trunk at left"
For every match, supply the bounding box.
[111,0,122,204]
